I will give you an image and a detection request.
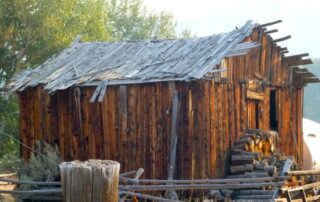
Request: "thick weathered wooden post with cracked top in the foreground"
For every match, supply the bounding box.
[59,159,120,202]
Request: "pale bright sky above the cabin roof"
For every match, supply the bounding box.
[144,0,320,58]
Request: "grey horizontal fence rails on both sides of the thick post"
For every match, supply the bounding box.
[0,169,320,202]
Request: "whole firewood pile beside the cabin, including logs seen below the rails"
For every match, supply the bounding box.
[227,129,283,201]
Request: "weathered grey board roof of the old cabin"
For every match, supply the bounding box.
[7,21,258,92]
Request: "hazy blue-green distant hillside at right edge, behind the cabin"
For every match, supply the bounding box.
[303,58,320,123]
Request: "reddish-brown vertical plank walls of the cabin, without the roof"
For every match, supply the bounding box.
[19,26,303,179]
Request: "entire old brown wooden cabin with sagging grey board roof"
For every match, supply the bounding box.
[7,21,319,179]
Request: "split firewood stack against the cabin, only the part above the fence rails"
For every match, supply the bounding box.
[228,129,277,178]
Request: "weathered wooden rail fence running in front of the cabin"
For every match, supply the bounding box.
[0,169,320,202]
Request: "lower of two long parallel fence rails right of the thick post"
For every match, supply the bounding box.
[119,181,284,191]
